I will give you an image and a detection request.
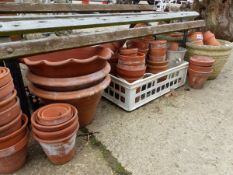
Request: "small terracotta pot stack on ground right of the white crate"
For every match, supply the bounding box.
[188,56,214,89]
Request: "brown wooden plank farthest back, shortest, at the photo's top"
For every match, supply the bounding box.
[0,3,156,13]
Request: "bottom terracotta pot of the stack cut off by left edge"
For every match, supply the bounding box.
[0,130,29,173]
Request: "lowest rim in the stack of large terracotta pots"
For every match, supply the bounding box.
[28,75,111,100]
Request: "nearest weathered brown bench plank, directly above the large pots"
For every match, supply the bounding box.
[0,20,205,59]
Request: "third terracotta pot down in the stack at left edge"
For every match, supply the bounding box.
[0,90,17,113]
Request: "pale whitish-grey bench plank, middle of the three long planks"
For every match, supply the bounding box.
[0,12,199,36]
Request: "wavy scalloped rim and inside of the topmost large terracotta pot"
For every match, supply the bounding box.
[22,46,113,66]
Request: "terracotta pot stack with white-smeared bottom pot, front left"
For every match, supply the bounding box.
[31,103,79,164]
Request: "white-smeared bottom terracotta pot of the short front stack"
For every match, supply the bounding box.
[33,129,78,165]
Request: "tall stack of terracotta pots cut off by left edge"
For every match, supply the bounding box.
[0,67,28,173]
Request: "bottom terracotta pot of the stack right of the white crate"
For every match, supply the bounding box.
[188,69,212,89]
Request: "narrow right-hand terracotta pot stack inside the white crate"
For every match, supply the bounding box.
[147,40,168,74]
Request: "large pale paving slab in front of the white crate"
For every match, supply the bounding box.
[88,51,233,175]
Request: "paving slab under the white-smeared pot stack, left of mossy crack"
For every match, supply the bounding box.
[14,132,114,175]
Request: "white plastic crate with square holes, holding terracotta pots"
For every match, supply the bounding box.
[103,62,188,111]
